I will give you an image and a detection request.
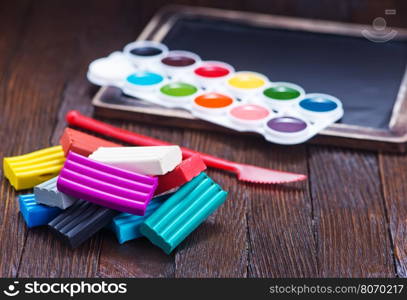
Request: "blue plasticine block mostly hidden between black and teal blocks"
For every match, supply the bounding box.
[108,195,168,244]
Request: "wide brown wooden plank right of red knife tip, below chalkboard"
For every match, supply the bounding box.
[309,147,394,277]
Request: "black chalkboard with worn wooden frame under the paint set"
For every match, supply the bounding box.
[92,6,407,152]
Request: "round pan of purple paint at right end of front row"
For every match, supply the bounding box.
[264,116,309,142]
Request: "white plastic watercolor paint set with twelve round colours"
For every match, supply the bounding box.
[87,41,343,145]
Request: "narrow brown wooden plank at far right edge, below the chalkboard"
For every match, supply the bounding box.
[379,153,407,278]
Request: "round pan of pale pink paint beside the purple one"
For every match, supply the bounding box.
[228,104,270,128]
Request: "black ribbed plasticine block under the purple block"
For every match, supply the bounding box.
[48,199,118,248]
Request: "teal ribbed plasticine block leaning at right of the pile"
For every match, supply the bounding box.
[140,172,228,254]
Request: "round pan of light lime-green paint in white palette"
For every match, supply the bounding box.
[159,82,199,104]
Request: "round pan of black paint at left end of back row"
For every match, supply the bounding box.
[123,41,168,66]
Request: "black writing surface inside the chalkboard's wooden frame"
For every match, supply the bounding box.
[163,16,407,129]
